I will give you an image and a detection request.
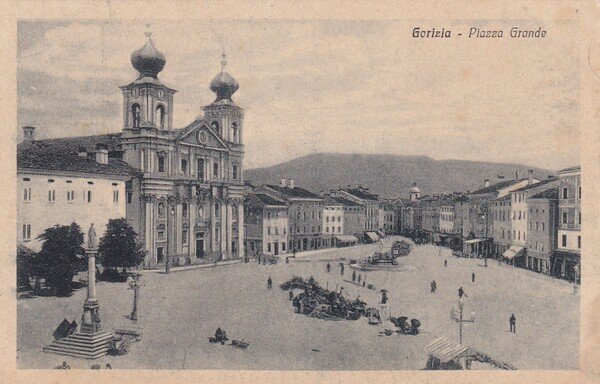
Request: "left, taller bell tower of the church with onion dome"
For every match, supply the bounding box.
[120,27,177,131]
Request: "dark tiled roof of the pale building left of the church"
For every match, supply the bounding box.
[17,134,141,176]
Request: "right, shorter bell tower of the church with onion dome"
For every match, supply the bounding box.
[202,52,244,145]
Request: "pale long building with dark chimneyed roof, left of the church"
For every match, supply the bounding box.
[17,127,140,251]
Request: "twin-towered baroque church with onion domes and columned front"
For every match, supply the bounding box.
[120,33,244,267]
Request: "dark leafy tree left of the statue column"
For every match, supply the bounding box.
[36,223,85,294]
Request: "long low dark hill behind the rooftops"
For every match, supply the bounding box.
[244,153,552,198]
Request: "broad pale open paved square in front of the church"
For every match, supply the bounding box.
[17,237,579,370]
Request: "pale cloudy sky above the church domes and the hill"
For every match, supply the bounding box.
[17,19,580,170]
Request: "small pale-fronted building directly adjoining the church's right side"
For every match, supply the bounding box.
[244,193,288,256]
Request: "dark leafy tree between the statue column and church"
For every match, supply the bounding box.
[98,219,146,269]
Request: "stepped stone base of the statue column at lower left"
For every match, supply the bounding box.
[43,331,113,359]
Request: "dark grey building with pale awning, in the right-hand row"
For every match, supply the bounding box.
[463,178,539,256]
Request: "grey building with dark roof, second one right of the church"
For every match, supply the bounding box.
[257,179,323,252]
